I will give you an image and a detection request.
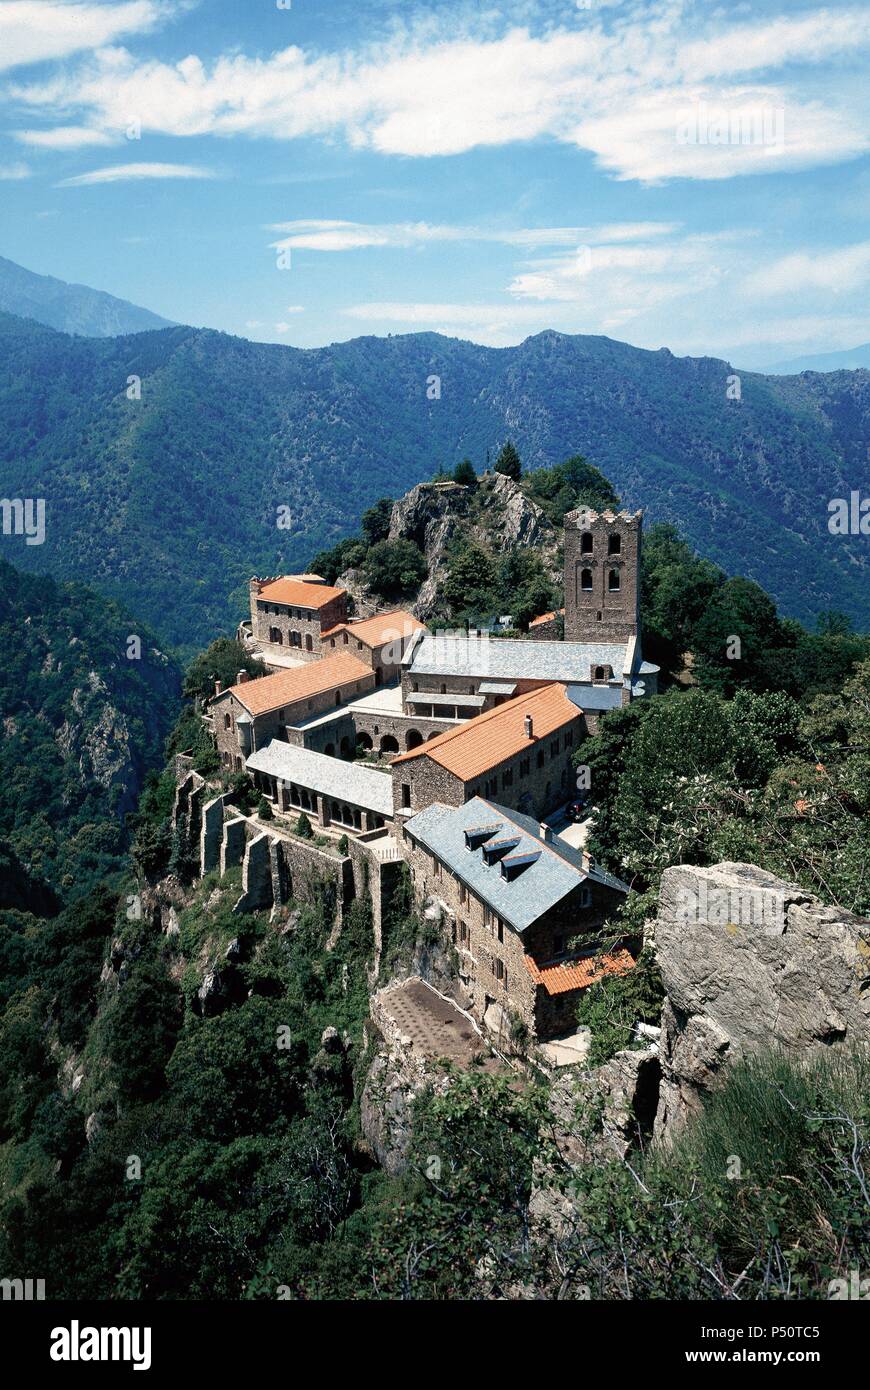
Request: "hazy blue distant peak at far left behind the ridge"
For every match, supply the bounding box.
[0,256,171,338]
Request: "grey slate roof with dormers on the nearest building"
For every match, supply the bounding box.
[404,796,628,931]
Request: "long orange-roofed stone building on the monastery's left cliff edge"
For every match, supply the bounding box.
[208,652,375,770]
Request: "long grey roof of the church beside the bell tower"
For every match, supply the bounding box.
[407,632,625,684]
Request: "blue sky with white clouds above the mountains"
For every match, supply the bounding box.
[0,0,870,367]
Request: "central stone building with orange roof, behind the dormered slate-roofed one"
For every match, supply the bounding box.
[391,682,585,817]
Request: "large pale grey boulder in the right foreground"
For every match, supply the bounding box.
[656,863,870,1141]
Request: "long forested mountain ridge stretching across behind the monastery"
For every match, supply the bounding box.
[0,316,870,646]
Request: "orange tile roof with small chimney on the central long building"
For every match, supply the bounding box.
[391,682,582,781]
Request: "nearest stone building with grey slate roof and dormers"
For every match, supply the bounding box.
[400,796,634,1041]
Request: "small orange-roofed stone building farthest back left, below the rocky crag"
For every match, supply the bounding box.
[249,574,347,666]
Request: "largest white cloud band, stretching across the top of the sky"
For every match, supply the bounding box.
[8,0,870,181]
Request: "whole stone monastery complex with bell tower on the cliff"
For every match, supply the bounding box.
[203,507,659,1041]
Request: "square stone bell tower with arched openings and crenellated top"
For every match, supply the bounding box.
[564,507,643,649]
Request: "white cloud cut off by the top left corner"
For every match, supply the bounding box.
[0,0,167,70]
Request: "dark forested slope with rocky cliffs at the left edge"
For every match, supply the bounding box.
[0,560,181,895]
